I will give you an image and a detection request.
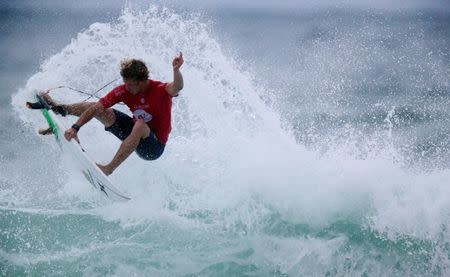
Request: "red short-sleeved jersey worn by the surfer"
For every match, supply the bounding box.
[99,80,172,144]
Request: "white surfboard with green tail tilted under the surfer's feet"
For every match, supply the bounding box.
[27,94,131,201]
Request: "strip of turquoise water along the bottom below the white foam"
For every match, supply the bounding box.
[1,206,449,276]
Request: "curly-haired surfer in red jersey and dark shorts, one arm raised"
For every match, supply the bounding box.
[42,52,184,175]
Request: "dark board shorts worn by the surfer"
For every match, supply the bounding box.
[105,109,166,160]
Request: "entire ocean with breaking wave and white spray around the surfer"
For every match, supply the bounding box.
[0,1,450,276]
